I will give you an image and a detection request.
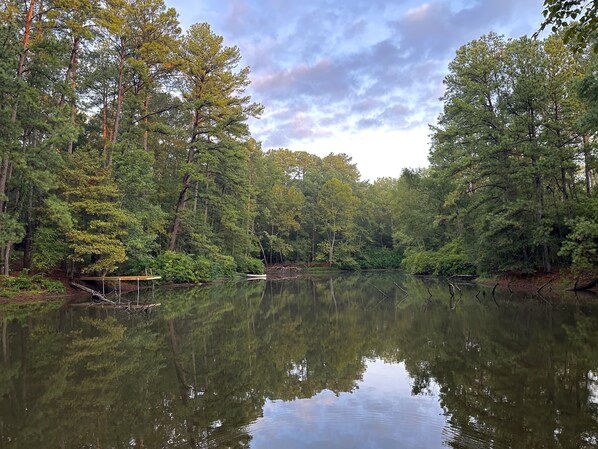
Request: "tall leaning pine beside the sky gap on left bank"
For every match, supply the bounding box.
[168,23,261,250]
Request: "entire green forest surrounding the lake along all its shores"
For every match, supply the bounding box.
[0,0,598,282]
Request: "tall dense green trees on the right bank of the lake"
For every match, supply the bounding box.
[398,34,598,273]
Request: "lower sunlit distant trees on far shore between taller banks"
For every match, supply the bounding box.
[252,149,393,268]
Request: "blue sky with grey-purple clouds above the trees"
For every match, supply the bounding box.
[165,0,542,180]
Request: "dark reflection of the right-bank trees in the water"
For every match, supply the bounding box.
[392,294,598,448]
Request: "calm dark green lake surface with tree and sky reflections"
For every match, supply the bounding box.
[0,273,598,449]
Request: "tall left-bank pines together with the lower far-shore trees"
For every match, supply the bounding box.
[0,0,404,281]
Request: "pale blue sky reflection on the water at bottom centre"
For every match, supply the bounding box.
[248,360,446,449]
